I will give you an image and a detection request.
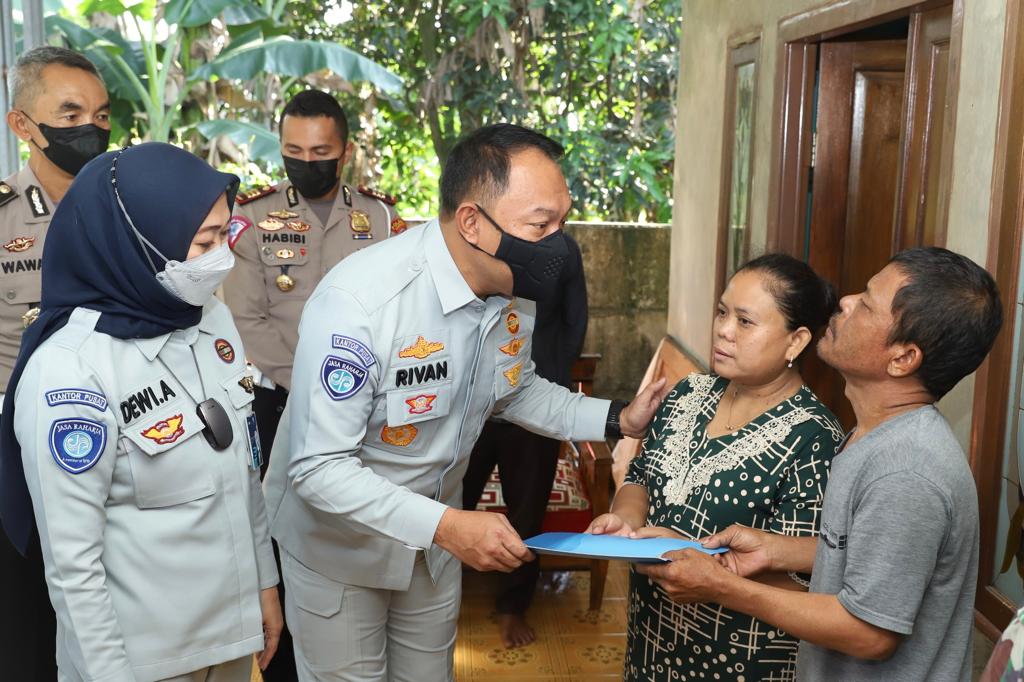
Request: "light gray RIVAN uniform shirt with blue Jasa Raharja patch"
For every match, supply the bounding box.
[266,220,609,590]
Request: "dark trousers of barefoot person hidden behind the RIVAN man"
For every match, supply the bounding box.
[462,421,561,615]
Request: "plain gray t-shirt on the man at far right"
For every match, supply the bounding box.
[797,407,979,682]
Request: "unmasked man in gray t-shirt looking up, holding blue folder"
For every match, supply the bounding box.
[637,248,1002,682]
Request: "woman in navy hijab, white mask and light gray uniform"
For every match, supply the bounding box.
[0,143,282,682]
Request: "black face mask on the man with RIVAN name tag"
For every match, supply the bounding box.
[476,206,569,301]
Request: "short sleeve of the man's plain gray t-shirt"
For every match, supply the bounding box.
[838,471,951,635]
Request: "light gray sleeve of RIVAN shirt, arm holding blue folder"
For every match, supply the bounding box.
[288,288,447,548]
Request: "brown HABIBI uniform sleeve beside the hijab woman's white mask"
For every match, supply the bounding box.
[224,212,292,388]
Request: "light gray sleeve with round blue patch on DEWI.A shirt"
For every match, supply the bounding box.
[14,346,135,682]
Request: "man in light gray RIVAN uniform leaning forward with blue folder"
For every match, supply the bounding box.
[267,125,664,681]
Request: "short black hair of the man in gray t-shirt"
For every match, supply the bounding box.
[889,247,1002,400]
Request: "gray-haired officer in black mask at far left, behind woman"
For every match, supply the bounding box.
[0,46,111,682]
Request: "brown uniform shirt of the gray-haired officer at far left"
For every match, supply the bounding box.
[0,166,55,394]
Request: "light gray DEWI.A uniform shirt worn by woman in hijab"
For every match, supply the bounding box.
[14,301,278,682]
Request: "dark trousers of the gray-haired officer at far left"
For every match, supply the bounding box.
[0,531,57,682]
